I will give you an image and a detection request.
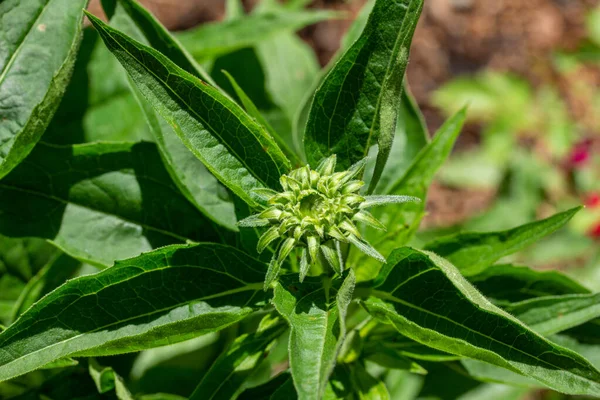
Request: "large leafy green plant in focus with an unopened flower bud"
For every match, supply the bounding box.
[0,0,600,400]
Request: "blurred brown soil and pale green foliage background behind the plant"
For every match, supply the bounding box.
[90,0,600,274]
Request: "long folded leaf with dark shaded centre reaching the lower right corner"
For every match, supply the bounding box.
[364,248,600,396]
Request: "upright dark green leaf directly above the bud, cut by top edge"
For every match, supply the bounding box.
[304,0,423,170]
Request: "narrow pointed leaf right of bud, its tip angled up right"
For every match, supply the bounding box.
[425,207,581,276]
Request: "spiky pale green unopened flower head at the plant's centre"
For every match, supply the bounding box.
[238,154,420,290]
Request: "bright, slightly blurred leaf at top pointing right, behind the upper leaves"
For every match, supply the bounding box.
[177,10,339,60]
